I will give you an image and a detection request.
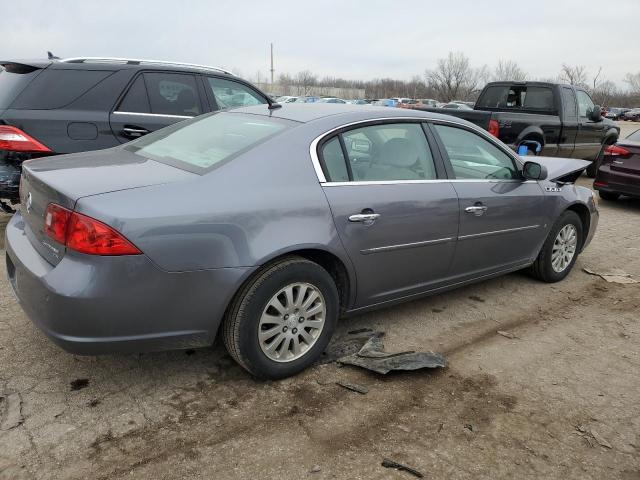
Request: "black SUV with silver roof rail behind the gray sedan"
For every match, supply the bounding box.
[0,58,270,212]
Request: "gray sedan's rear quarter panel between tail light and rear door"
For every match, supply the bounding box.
[76,126,349,272]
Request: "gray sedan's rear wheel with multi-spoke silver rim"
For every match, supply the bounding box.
[222,256,339,379]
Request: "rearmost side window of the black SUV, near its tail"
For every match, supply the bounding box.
[10,68,113,110]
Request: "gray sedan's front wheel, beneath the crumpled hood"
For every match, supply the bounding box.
[530,210,583,283]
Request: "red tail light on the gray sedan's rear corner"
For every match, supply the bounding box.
[44,203,142,255]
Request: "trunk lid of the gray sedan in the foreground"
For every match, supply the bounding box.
[20,147,195,265]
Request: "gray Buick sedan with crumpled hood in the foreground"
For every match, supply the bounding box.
[6,104,598,378]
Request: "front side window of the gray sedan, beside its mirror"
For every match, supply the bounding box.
[434,125,520,180]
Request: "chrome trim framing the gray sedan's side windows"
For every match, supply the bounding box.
[310,112,529,187]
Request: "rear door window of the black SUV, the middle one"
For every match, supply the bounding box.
[144,72,202,117]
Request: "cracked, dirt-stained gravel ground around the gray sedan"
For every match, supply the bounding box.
[0,124,640,480]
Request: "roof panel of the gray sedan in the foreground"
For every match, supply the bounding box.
[231,103,468,124]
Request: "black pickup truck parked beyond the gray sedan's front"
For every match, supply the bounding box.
[418,82,620,177]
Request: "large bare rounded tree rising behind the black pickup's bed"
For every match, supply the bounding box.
[425,52,488,102]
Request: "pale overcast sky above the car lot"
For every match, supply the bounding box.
[5,0,640,86]
